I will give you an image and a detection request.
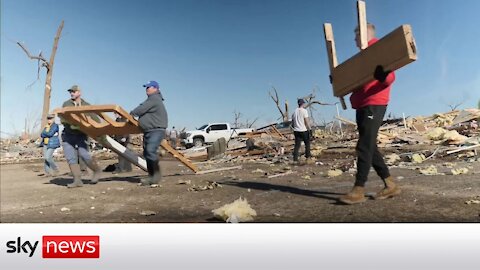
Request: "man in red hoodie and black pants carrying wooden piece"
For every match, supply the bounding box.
[339,23,400,204]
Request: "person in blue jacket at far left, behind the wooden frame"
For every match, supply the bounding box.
[40,114,60,176]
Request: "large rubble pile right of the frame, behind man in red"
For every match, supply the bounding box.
[178,109,480,177]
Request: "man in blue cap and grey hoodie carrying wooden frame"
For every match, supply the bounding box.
[130,81,168,185]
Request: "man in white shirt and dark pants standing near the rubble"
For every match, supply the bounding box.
[292,99,311,161]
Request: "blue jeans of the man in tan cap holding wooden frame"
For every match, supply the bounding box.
[62,133,92,164]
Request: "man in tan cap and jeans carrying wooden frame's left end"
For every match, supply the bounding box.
[62,85,101,188]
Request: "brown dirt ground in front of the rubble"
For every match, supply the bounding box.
[0,155,480,223]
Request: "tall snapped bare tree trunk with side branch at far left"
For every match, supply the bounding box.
[17,21,63,132]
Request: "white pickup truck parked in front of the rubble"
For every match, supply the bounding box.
[183,123,253,147]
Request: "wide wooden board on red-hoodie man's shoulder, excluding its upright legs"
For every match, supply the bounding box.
[327,24,417,97]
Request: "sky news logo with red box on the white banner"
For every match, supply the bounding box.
[6,235,100,259]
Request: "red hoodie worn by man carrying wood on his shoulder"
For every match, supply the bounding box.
[350,38,395,109]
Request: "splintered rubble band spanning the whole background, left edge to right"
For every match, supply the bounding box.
[0,109,480,168]
